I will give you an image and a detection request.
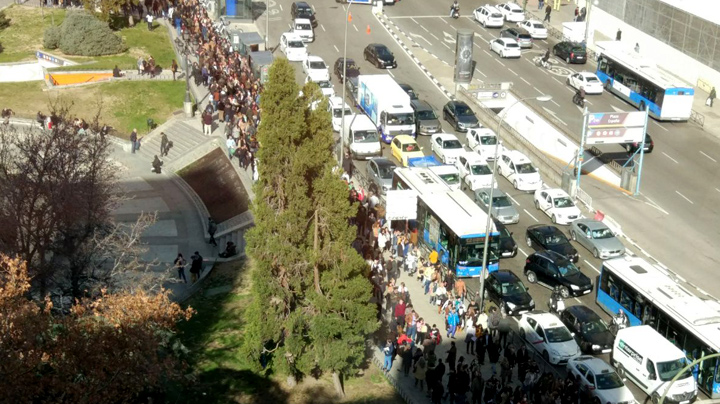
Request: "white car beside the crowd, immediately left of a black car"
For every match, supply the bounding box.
[518,311,584,364]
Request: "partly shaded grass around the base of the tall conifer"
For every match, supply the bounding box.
[168,262,403,404]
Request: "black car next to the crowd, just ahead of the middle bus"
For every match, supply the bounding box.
[485,270,535,316]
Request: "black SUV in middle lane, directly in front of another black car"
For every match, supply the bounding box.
[524,251,593,298]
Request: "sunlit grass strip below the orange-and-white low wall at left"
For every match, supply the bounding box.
[0,81,185,138]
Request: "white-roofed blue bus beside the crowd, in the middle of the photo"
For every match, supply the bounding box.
[393,167,500,278]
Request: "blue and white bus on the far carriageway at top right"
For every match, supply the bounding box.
[595,42,695,121]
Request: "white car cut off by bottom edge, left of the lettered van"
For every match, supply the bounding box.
[567,355,639,404]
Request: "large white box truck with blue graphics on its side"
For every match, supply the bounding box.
[357,74,416,144]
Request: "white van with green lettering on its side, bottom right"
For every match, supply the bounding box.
[610,325,697,404]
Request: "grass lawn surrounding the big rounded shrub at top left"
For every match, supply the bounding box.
[0,5,175,70]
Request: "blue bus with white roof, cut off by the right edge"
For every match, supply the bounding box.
[596,256,720,399]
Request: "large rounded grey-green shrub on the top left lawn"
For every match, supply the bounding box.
[59,11,123,56]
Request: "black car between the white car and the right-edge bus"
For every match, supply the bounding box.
[560,304,615,354]
